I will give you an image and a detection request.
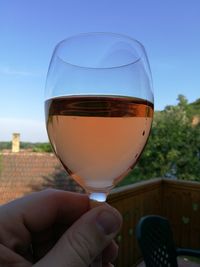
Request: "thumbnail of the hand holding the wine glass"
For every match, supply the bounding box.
[96,209,121,235]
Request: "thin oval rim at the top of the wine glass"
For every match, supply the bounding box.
[54,32,148,70]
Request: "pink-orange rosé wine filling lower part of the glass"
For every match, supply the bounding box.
[45,96,153,192]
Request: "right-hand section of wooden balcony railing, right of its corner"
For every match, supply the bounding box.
[162,180,200,249]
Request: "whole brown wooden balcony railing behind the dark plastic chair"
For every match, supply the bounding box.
[108,179,200,267]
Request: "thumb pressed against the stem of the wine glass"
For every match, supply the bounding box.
[35,204,122,267]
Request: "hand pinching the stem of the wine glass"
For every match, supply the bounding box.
[0,190,122,267]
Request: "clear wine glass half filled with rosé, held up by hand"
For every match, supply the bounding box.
[45,33,153,266]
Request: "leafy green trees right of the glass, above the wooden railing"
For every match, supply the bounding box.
[120,95,200,185]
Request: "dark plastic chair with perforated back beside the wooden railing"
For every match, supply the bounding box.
[136,215,200,267]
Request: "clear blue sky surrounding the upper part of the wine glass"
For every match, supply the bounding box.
[0,0,200,141]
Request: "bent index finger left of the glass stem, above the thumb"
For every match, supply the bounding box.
[2,189,89,231]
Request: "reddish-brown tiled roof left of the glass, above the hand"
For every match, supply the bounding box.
[0,152,82,204]
